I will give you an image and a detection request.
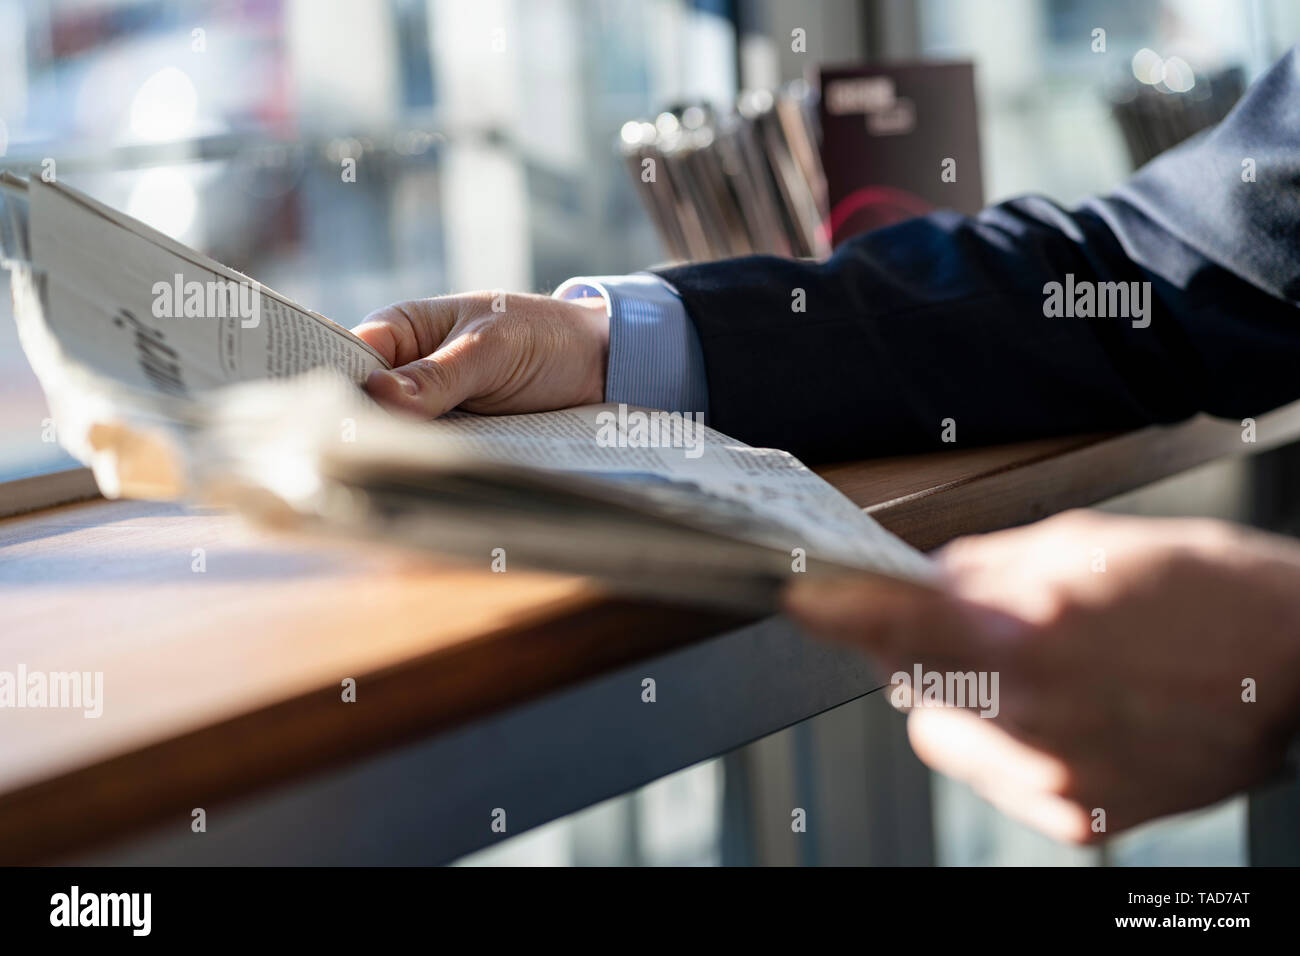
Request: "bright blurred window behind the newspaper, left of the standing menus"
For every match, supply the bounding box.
[0,0,736,479]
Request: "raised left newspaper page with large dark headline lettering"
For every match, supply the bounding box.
[0,176,387,497]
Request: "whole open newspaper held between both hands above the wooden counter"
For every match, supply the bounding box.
[0,174,931,611]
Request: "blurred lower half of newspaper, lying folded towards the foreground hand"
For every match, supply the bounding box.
[191,376,931,609]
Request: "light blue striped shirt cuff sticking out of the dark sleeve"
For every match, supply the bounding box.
[554,272,709,416]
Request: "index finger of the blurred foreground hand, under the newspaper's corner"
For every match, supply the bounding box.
[785,576,1023,669]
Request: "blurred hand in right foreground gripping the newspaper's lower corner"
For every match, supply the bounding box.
[788,511,1300,843]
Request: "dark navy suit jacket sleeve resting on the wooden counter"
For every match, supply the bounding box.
[659,51,1300,460]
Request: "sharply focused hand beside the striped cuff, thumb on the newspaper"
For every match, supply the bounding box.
[352,293,610,418]
